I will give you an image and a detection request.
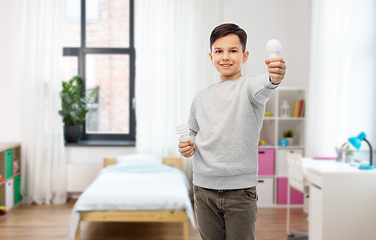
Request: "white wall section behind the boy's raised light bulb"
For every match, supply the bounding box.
[223,0,312,87]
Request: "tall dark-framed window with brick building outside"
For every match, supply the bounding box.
[63,0,136,141]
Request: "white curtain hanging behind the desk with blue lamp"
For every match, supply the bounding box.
[306,0,376,156]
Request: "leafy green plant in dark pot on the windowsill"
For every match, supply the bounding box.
[59,76,99,142]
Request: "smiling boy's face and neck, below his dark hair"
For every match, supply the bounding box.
[209,34,249,82]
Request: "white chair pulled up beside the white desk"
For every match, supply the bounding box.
[286,153,309,240]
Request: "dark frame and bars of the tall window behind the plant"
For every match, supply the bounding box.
[63,0,136,143]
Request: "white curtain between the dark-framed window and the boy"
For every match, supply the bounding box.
[135,0,222,191]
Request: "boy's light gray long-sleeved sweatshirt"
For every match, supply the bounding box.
[188,73,278,190]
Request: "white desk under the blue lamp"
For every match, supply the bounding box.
[303,158,376,240]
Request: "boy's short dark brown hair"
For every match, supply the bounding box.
[210,23,247,52]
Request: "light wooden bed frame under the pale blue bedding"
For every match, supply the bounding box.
[75,158,188,240]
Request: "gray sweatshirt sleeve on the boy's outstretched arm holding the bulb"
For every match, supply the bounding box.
[247,73,279,106]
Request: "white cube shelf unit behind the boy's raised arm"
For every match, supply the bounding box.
[259,87,307,207]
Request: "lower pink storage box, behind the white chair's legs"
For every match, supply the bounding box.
[277,177,304,204]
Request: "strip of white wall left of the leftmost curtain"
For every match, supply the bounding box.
[0,0,21,142]
